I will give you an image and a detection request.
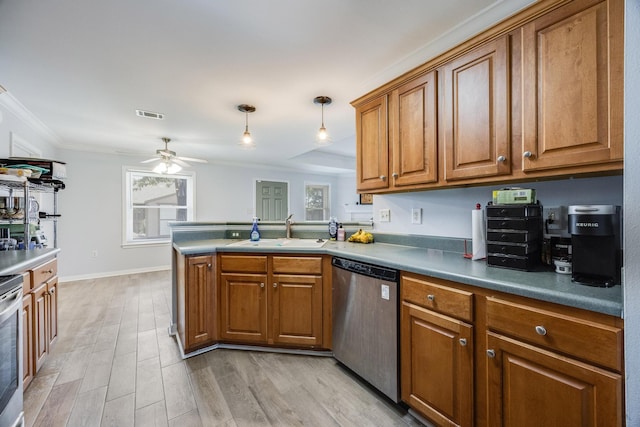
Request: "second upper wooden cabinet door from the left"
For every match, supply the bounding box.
[389,71,438,186]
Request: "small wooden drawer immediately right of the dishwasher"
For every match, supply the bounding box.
[400,276,473,322]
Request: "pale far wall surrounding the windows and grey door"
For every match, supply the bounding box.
[58,150,355,280]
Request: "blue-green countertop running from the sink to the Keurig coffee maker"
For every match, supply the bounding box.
[173,239,623,317]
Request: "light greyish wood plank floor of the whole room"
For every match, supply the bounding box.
[25,272,420,427]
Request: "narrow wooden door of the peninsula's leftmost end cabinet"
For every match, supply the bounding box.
[185,255,216,349]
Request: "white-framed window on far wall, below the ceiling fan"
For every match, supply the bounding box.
[124,169,195,245]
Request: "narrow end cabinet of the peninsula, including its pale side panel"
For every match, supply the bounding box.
[175,254,217,353]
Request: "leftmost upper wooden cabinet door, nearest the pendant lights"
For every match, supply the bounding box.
[356,95,389,191]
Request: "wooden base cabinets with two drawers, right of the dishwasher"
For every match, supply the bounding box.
[400,272,625,427]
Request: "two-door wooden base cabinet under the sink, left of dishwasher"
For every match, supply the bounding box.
[220,254,330,348]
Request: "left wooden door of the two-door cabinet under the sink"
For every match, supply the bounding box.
[220,273,267,343]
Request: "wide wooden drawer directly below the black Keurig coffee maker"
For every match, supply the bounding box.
[487,297,622,372]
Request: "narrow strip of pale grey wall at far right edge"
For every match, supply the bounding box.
[623,0,640,426]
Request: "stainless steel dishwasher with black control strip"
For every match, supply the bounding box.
[332,257,400,403]
